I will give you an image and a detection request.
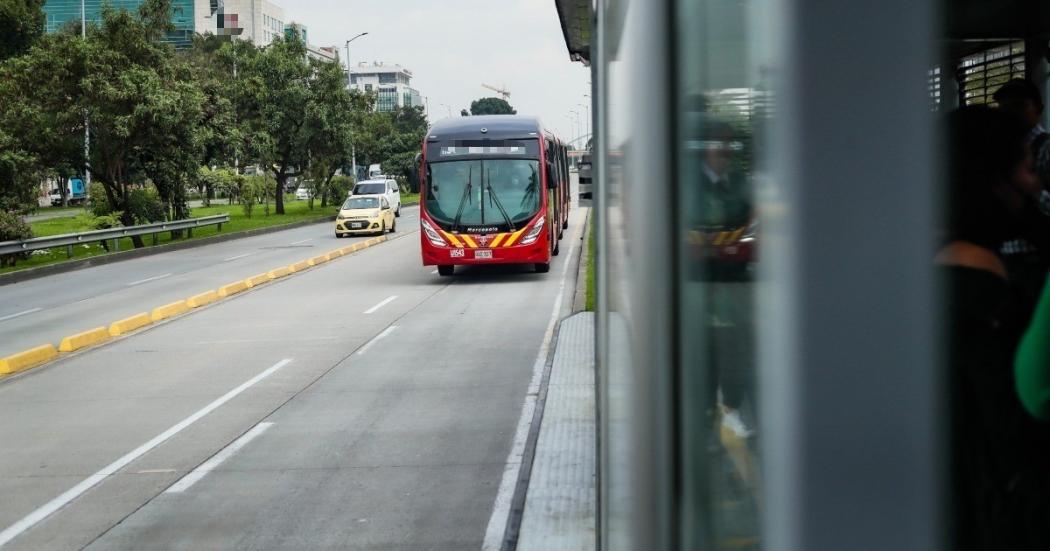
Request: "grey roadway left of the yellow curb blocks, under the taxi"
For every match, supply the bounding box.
[0,207,419,357]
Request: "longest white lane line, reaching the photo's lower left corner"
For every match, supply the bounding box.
[0,358,292,547]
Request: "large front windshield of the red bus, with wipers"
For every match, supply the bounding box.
[424,158,540,229]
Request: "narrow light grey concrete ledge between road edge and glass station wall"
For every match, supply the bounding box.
[518,312,597,551]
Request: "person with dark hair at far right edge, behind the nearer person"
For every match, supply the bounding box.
[993,79,1050,316]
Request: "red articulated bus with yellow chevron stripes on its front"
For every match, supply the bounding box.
[419,115,569,276]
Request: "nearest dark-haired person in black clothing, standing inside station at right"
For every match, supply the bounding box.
[936,107,1050,551]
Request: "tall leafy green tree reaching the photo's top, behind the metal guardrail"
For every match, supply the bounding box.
[79,0,205,242]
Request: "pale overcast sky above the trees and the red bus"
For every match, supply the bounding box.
[283,0,590,144]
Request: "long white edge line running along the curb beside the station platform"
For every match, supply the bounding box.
[481,226,573,551]
